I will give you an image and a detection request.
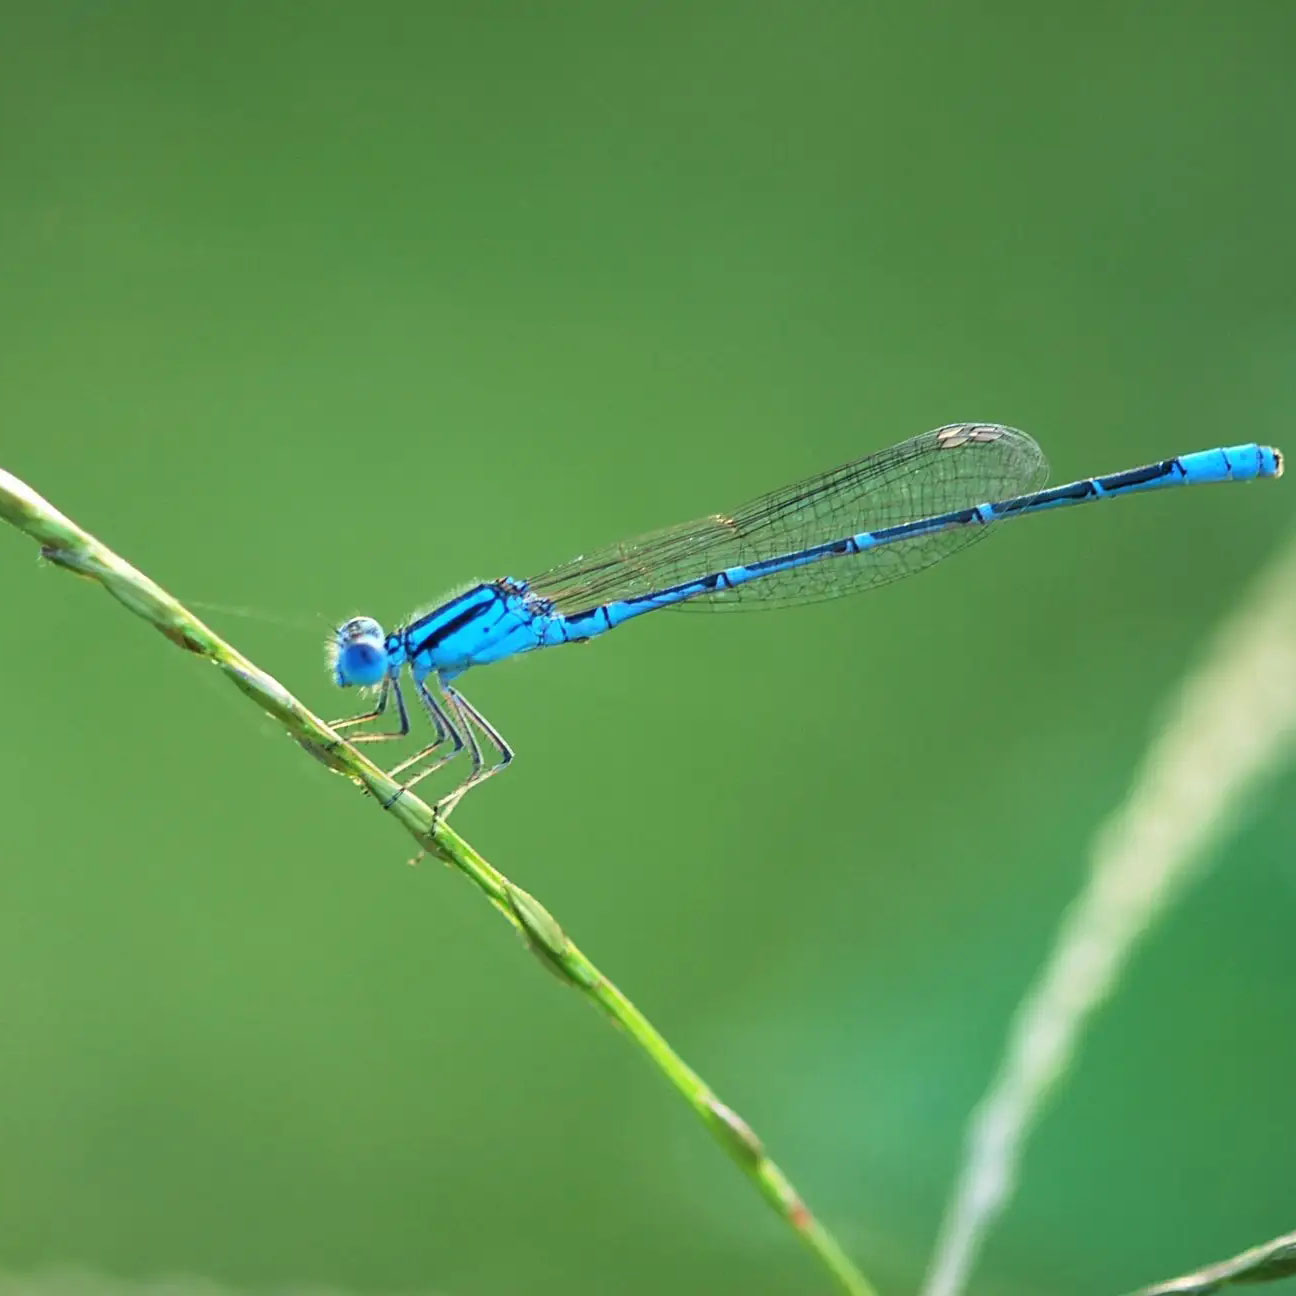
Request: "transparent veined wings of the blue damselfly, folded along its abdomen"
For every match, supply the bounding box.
[529,424,1048,613]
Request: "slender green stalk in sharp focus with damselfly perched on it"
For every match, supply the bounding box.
[0,469,874,1296]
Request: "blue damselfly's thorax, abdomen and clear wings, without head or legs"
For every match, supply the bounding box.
[388,424,1283,678]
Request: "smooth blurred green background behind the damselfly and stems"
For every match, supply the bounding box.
[0,0,1296,1296]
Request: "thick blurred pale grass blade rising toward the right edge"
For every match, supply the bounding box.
[924,526,1296,1296]
